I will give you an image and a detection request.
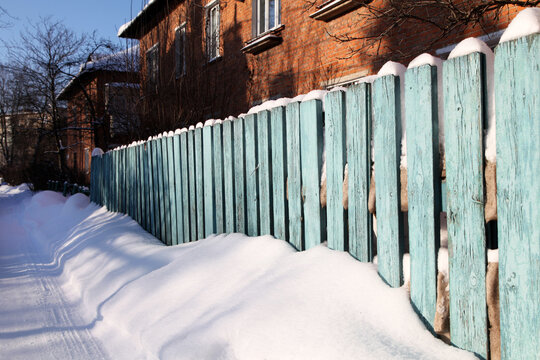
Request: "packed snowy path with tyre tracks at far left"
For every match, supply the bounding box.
[0,188,108,359]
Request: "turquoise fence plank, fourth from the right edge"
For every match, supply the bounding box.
[373,75,404,287]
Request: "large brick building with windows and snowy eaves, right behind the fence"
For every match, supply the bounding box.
[118,0,519,134]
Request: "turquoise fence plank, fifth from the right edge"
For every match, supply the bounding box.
[346,83,373,262]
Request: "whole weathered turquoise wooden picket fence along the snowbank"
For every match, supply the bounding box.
[91,34,540,359]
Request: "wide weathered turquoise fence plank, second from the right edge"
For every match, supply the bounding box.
[442,53,488,358]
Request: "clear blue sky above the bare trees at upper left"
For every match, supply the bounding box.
[0,0,144,57]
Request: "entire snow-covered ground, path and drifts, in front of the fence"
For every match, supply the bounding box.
[0,185,474,360]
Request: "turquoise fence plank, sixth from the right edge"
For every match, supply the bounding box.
[325,90,348,251]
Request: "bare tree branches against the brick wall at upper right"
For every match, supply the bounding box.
[304,0,540,59]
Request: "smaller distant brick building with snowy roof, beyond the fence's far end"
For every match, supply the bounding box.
[58,47,141,184]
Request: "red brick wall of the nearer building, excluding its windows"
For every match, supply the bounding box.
[136,0,519,134]
